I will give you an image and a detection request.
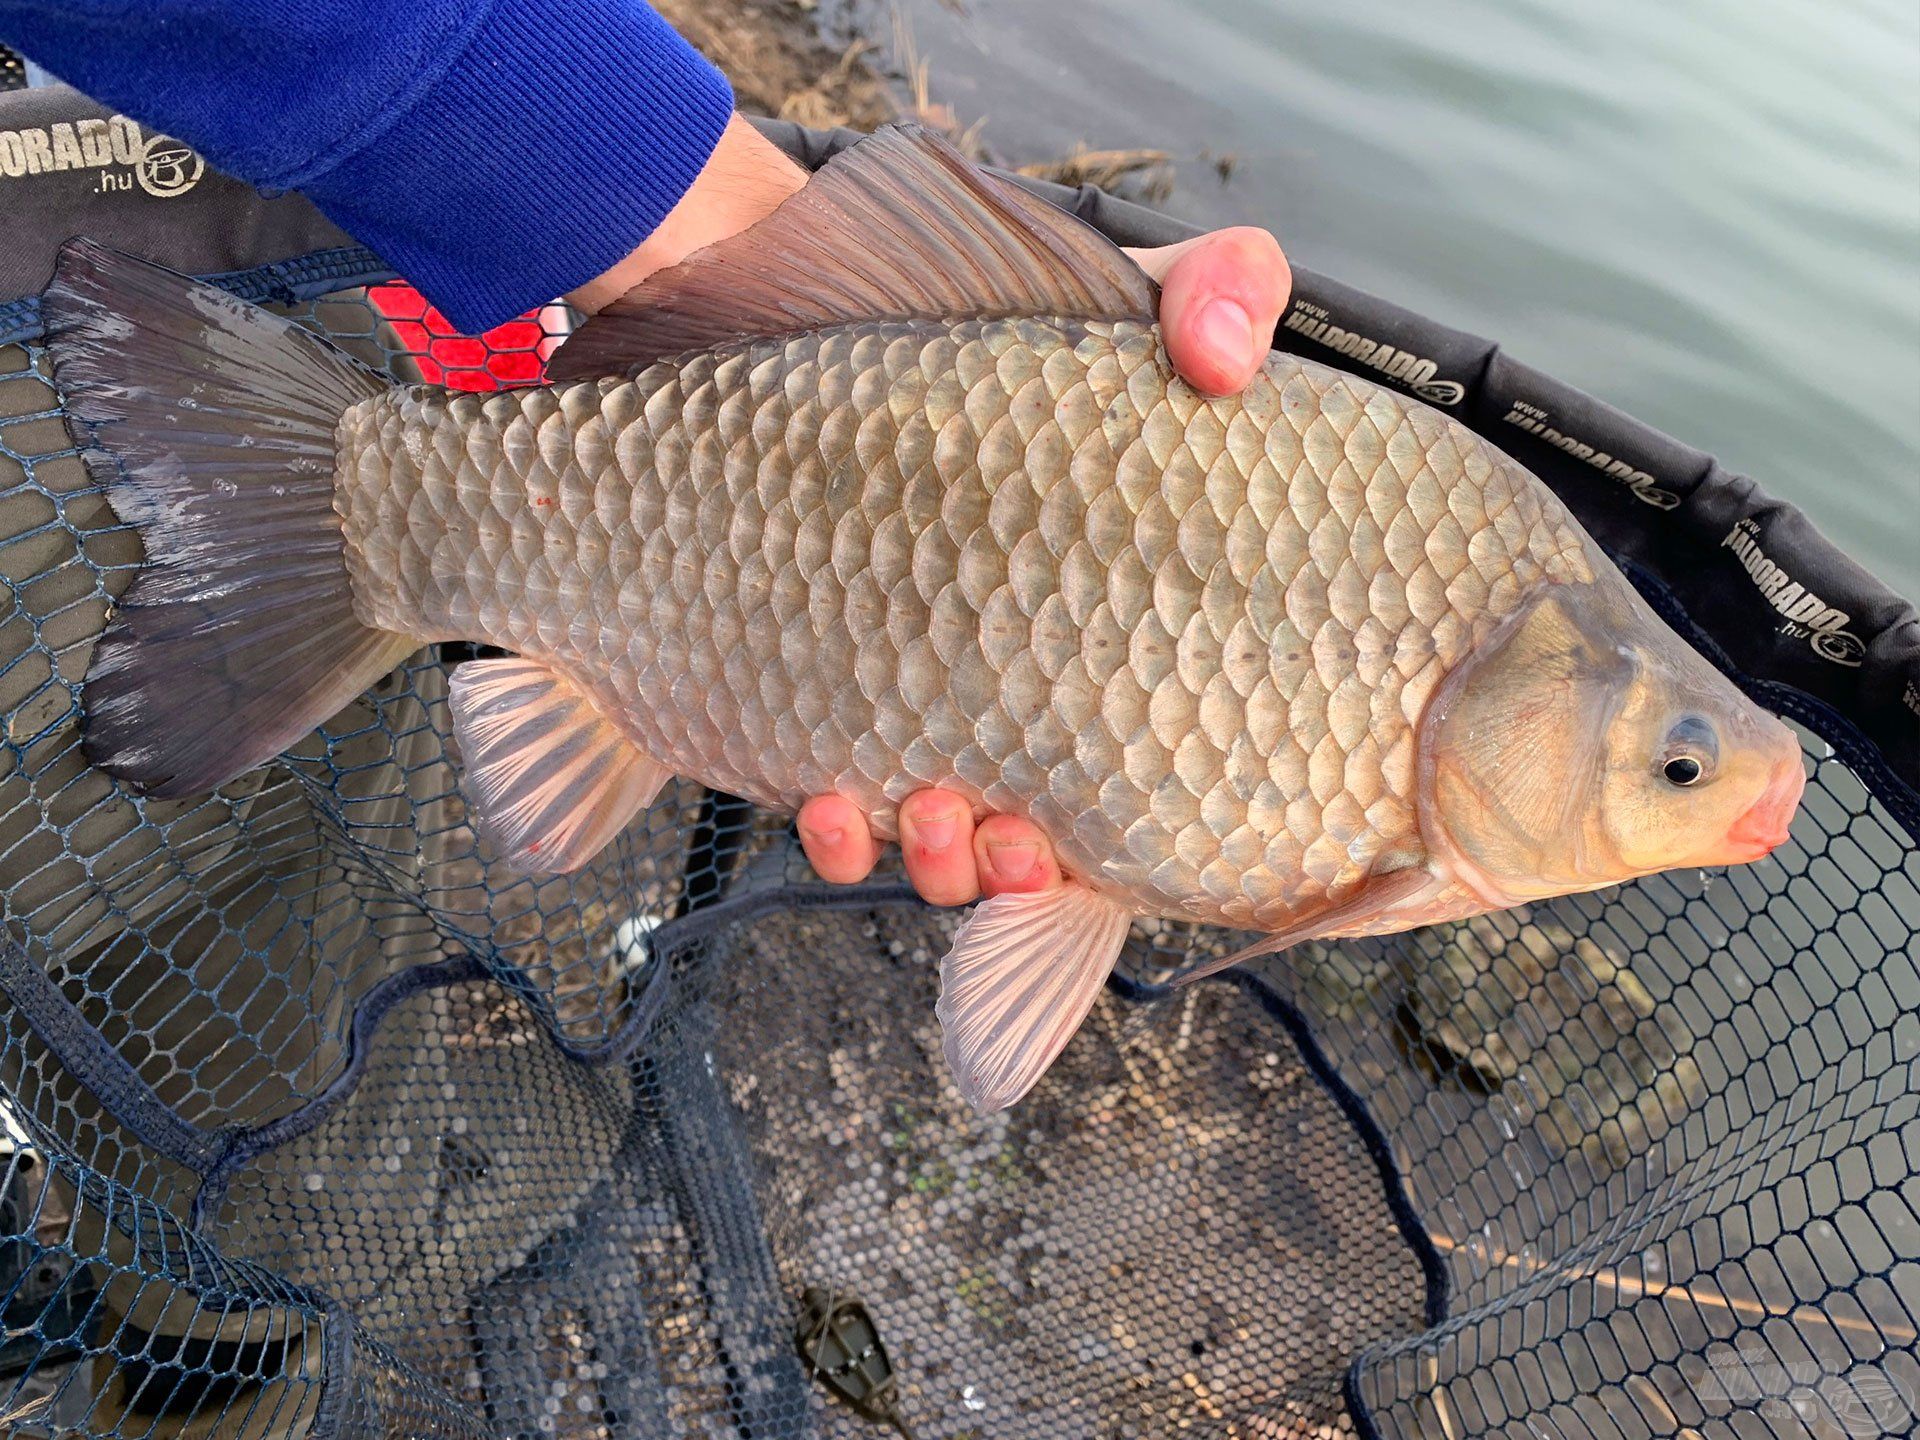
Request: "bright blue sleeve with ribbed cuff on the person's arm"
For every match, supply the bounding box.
[0,0,733,332]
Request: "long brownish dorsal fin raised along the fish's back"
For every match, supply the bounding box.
[547,125,1156,380]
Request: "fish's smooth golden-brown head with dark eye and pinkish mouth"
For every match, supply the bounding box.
[1421,566,1805,904]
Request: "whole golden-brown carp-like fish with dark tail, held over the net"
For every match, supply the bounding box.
[44,127,1803,1110]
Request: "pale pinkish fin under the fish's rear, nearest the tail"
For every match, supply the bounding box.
[449,659,672,874]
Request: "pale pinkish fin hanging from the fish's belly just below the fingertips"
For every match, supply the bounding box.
[935,883,1133,1114]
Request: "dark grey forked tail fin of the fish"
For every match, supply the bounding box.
[40,240,415,797]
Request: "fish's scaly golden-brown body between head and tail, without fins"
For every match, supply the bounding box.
[340,319,1596,927]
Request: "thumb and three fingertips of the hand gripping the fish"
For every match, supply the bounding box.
[799,227,1292,904]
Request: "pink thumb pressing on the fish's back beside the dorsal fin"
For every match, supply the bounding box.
[1135,225,1294,396]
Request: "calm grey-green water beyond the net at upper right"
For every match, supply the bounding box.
[829,0,1920,597]
